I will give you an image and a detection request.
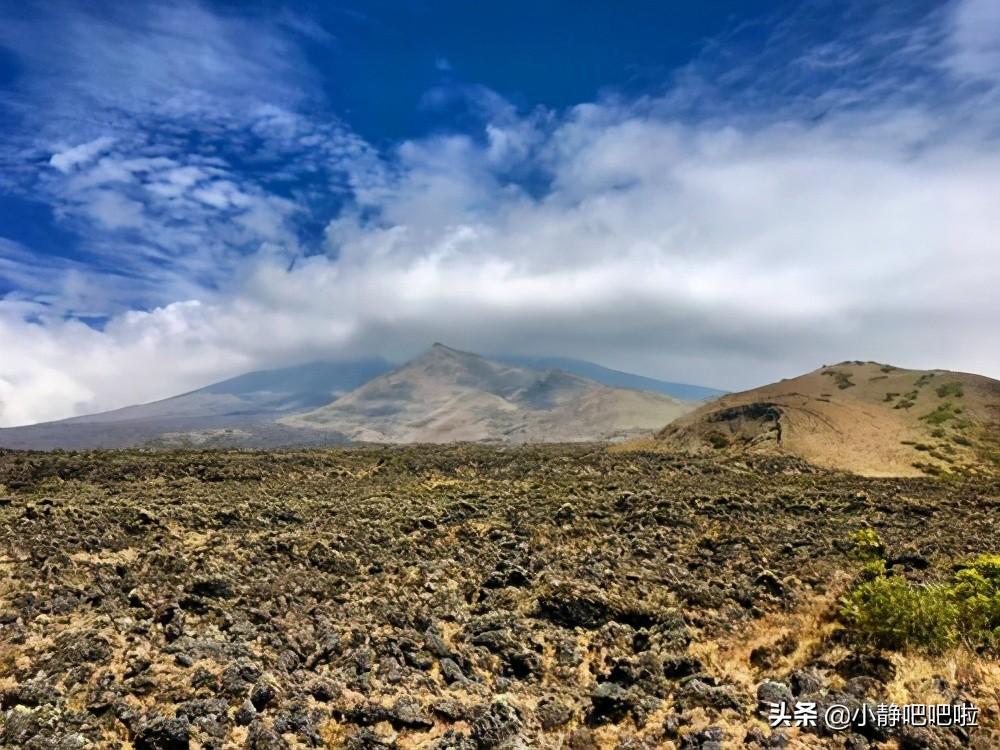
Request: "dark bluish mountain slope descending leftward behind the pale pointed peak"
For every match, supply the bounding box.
[0,358,392,450]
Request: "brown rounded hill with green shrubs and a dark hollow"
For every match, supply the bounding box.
[657,362,1000,476]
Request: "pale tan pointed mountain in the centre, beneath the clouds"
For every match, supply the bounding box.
[278,344,692,443]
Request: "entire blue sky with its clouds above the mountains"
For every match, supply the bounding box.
[0,0,1000,425]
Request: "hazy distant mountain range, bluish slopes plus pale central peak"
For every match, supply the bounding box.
[0,344,712,449]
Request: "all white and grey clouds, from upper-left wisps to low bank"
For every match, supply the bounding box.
[0,0,1000,425]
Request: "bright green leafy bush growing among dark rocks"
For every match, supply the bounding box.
[840,555,1000,652]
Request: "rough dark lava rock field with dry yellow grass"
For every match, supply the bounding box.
[0,446,1000,750]
